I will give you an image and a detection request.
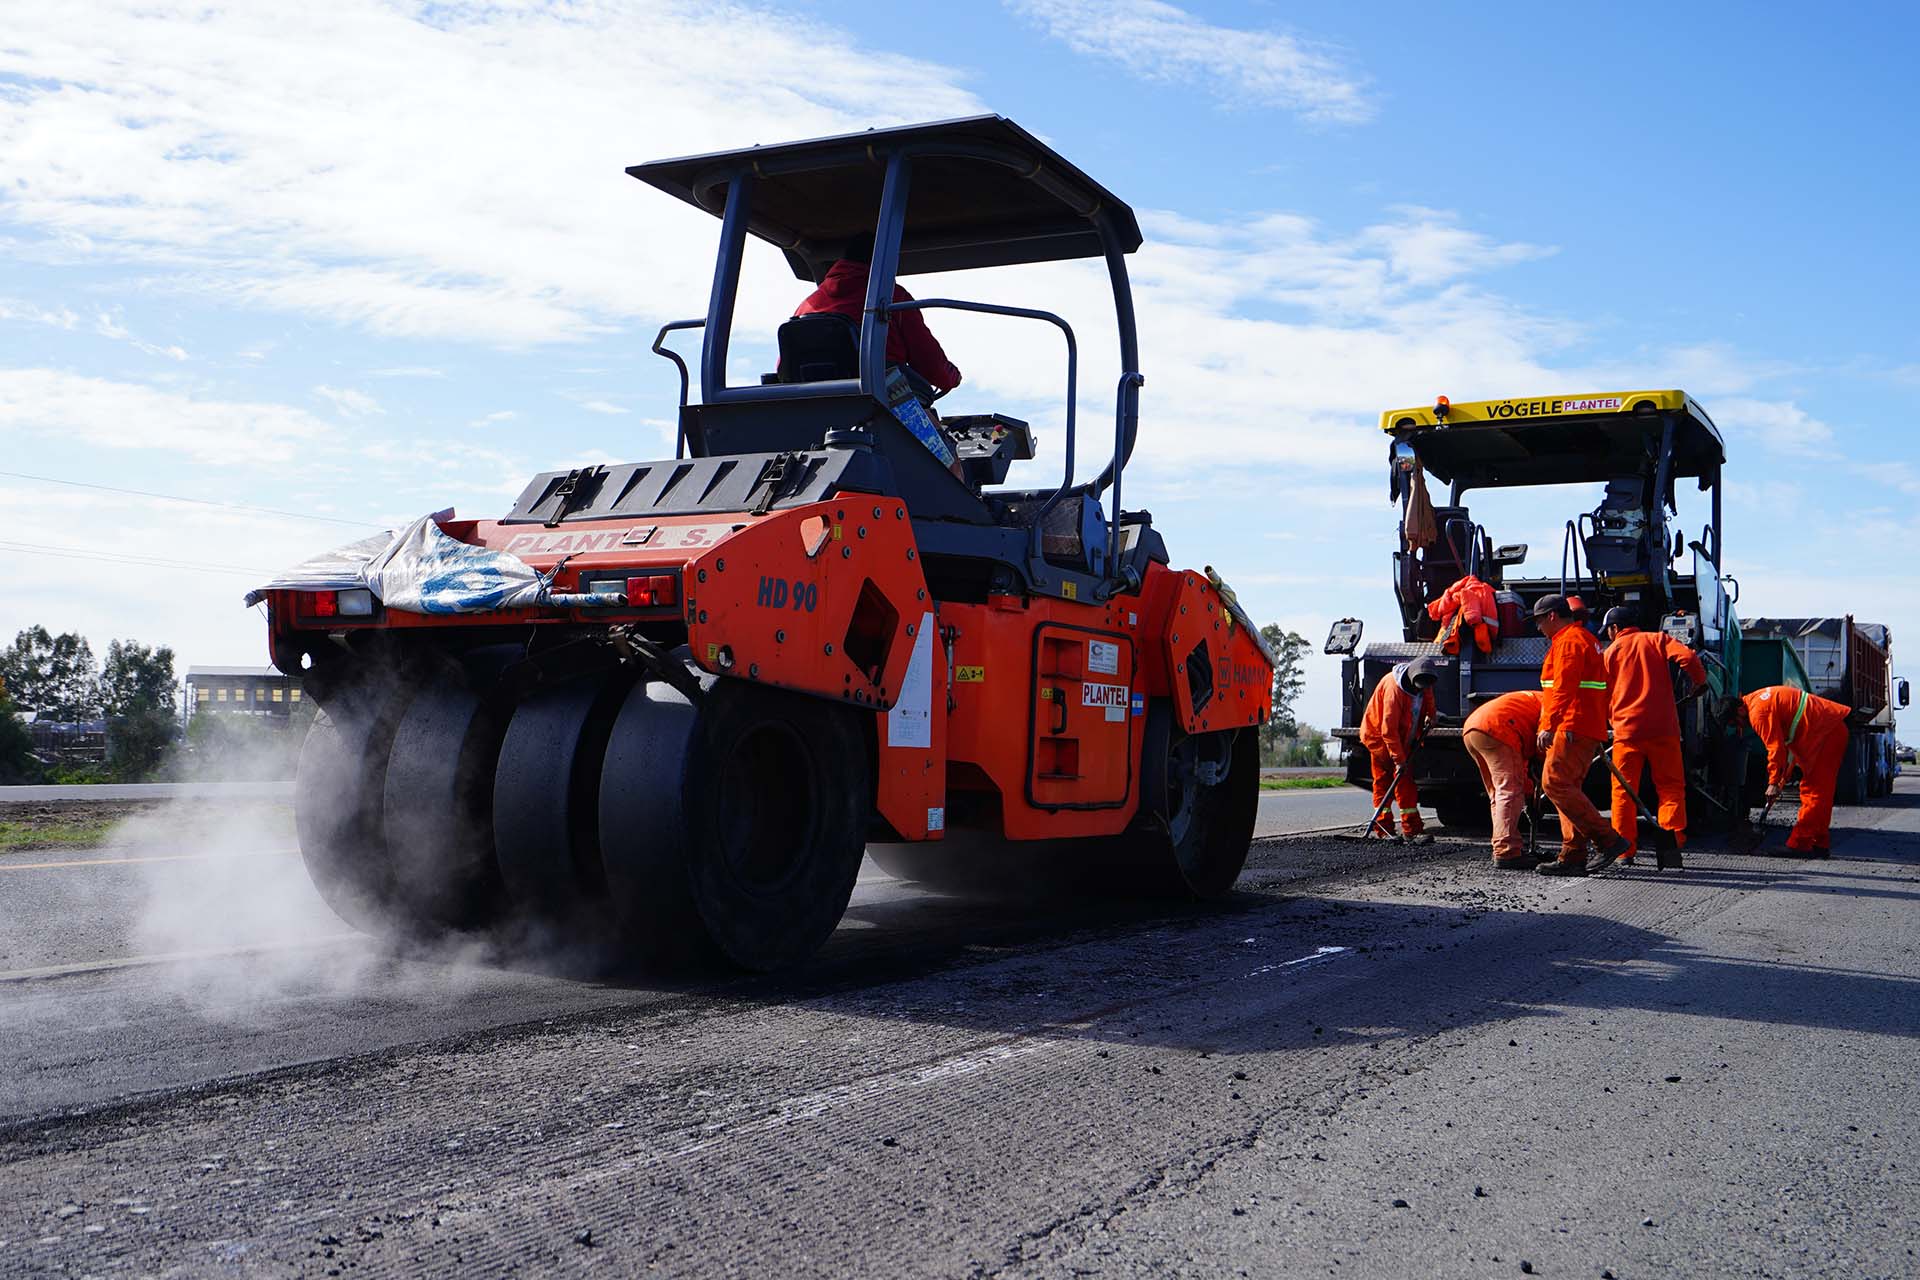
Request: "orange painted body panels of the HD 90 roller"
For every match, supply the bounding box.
[269,495,1273,841]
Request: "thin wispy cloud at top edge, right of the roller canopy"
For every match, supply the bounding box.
[1006,0,1375,125]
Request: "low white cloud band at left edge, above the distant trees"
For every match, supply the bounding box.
[0,368,332,464]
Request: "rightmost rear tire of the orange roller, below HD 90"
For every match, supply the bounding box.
[601,679,870,971]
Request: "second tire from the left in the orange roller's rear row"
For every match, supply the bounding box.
[384,674,505,936]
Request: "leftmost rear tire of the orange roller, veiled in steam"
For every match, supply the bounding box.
[294,695,405,935]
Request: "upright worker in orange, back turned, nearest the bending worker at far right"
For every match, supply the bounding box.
[1599,608,1707,862]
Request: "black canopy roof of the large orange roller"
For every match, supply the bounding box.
[628,115,1140,280]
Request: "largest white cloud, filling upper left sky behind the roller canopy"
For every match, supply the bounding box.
[0,0,981,345]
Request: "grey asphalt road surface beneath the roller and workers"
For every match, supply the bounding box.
[0,779,1920,1280]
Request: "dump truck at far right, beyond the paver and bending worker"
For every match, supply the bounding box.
[1741,614,1910,804]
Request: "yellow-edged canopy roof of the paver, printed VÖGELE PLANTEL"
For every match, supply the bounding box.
[1380,391,1726,489]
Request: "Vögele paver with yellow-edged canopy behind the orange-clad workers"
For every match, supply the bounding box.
[1327,390,1747,831]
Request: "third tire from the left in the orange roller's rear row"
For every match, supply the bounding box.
[493,676,632,940]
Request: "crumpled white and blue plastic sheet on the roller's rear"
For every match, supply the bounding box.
[246,516,547,614]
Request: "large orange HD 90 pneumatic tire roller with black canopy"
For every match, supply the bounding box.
[250,115,1273,969]
